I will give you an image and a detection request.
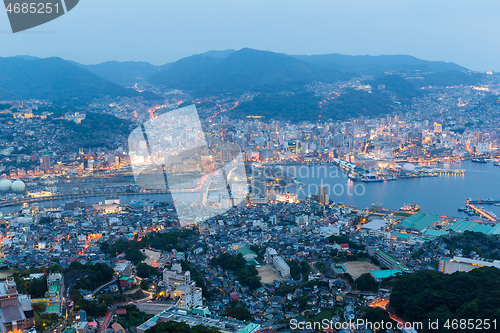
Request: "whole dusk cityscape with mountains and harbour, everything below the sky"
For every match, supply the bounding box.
[0,1,500,333]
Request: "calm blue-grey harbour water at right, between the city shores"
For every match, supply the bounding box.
[283,161,500,217]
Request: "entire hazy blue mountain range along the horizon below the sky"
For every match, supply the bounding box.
[0,49,476,102]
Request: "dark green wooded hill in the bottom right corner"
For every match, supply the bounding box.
[389,267,500,332]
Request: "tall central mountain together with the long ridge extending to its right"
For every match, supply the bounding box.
[148,48,472,97]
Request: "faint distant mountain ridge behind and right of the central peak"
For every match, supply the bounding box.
[293,53,468,75]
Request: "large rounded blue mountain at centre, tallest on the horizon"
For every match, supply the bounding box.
[148,49,348,96]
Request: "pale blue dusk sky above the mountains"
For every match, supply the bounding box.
[0,0,500,71]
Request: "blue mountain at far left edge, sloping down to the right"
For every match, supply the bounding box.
[0,57,159,103]
